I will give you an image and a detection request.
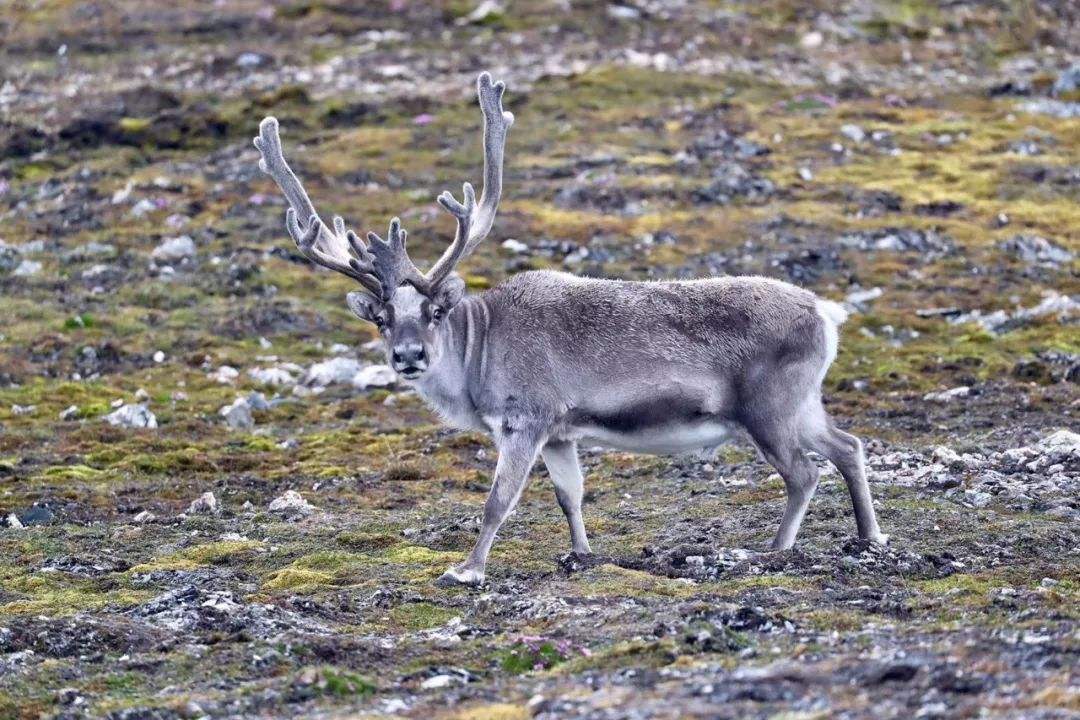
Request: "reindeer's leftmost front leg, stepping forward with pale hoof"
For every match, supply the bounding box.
[435,429,542,587]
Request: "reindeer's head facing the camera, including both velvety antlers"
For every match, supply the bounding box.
[255,72,514,380]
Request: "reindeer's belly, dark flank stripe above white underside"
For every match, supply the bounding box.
[566,393,734,454]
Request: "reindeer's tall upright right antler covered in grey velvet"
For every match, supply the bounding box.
[424,72,514,285]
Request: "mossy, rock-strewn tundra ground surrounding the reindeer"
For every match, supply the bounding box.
[0,0,1080,720]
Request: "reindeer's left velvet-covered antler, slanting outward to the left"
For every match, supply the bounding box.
[255,118,383,296]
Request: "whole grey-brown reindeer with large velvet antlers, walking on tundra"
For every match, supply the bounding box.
[255,72,888,585]
